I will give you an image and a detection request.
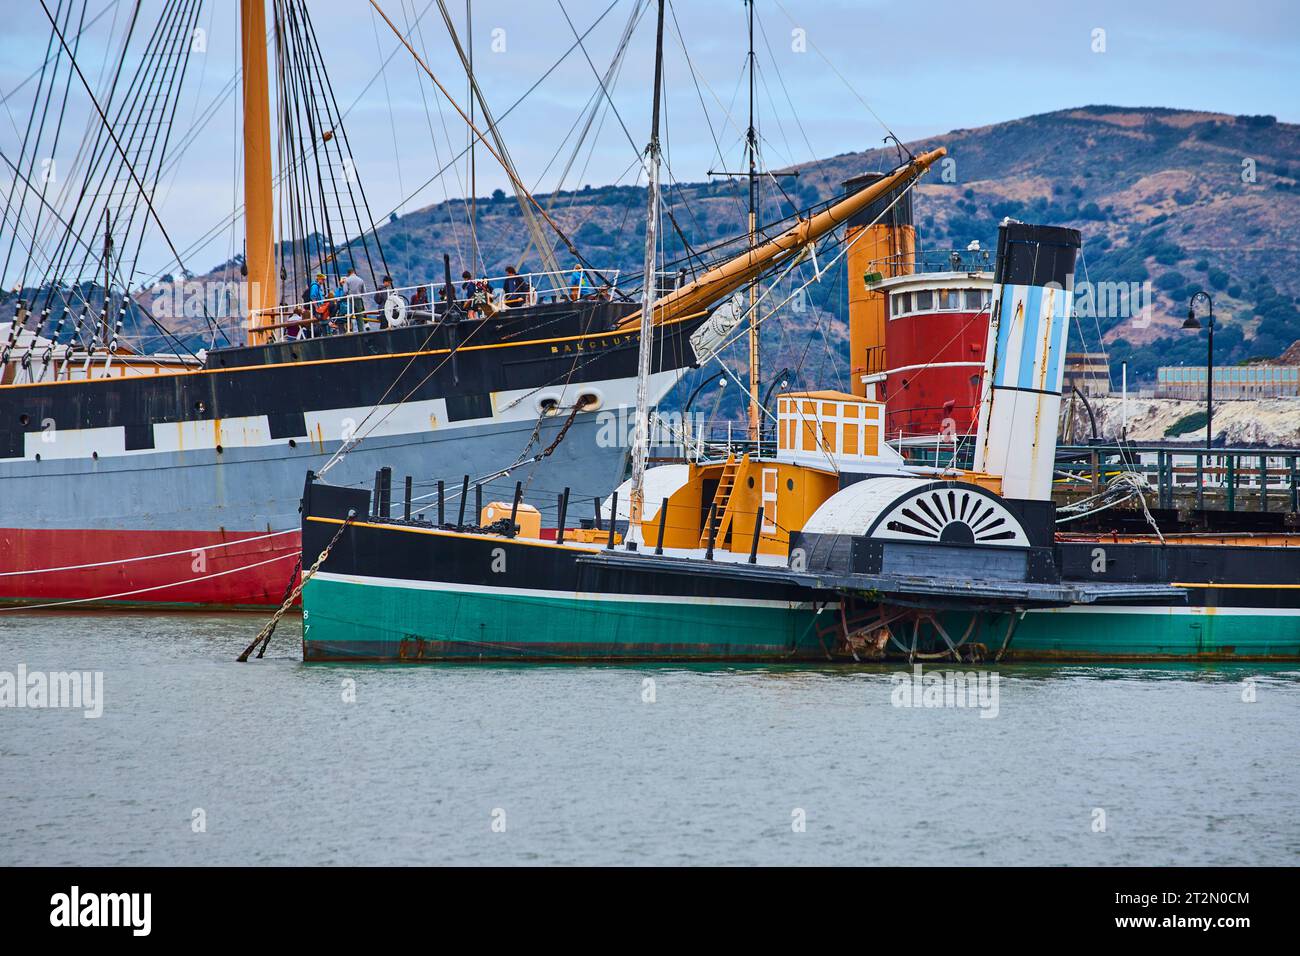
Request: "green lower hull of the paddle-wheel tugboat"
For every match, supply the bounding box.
[303,575,1300,662]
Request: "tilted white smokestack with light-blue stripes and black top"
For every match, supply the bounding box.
[975,221,1079,501]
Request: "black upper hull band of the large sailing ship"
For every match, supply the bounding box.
[0,303,703,459]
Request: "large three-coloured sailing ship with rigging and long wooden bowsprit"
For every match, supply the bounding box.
[0,0,780,606]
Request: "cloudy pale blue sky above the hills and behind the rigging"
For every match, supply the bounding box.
[0,0,1300,280]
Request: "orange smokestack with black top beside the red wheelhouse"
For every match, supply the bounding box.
[844,173,917,398]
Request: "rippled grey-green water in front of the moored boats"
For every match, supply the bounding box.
[0,611,1300,865]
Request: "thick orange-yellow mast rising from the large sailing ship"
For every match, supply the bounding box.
[239,0,277,345]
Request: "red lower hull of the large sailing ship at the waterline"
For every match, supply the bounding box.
[0,528,300,607]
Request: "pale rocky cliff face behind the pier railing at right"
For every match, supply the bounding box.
[1062,395,1300,447]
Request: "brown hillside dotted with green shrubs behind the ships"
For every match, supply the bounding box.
[165,107,1300,408]
